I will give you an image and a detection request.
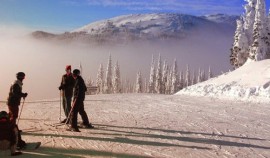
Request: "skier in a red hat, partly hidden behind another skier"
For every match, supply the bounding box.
[58,65,75,123]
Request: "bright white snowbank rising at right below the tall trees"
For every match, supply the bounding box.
[176,60,270,102]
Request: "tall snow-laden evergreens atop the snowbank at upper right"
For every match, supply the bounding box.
[230,0,270,68]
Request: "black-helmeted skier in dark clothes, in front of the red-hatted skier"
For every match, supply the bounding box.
[67,69,94,132]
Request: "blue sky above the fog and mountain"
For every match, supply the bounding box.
[0,0,270,32]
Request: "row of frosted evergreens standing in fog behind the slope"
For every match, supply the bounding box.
[87,55,212,94]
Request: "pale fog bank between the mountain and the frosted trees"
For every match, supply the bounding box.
[0,27,232,101]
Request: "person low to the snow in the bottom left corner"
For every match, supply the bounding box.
[0,111,22,156]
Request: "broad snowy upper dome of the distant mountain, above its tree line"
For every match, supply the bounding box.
[73,14,215,37]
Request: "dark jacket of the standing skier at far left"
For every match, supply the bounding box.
[7,80,25,106]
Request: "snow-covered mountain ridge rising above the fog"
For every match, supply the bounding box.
[33,14,238,42]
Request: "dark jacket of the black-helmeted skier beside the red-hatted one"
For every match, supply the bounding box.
[73,76,87,101]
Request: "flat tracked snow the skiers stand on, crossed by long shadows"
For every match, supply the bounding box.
[0,94,270,158]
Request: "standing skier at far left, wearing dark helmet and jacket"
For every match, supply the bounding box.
[7,72,28,125]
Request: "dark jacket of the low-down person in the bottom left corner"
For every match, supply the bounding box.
[0,118,16,145]
